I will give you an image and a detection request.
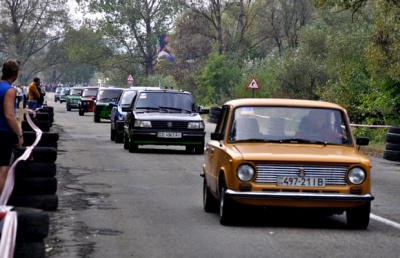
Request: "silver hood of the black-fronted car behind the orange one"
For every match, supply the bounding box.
[135,112,202,121]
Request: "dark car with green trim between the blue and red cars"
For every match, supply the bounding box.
[93,87,123,123]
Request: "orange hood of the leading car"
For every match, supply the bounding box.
[233,143,369,163]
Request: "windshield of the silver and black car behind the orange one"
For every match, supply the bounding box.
[136,92,194,113]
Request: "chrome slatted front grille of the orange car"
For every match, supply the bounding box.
[255,164,347,186]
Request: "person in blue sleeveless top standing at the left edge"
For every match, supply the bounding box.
[0,59,24,193]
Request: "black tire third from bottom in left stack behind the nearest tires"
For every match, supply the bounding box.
[15,160,57,178]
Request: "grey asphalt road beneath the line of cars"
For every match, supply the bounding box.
[46,93,400,258]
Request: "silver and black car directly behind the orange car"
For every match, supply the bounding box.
[122,89,209,154]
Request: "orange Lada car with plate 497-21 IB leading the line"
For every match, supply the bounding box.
[201,99,374,229]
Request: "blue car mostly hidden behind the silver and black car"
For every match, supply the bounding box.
[109,86,159,143]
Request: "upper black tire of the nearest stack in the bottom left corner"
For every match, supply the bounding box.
[12,207,50,241]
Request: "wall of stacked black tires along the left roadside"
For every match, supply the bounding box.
[0,107,59,258]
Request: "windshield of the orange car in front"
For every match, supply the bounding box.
[229,106,352,145]
